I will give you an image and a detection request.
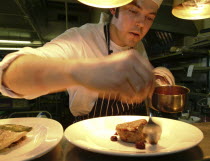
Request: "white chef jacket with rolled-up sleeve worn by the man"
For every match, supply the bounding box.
[0,23,147,116]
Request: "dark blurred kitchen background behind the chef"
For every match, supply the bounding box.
[0,0,210,126]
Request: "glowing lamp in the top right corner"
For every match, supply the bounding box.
[172,0,210,20]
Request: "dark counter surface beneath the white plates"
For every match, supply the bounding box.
[34,122,210,161]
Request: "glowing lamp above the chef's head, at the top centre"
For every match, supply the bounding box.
[78,0,133,8]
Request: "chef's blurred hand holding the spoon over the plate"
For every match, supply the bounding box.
[72,49,154,102]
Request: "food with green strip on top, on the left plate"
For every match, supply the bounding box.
[0,124,32,150]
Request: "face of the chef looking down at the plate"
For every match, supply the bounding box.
[110,0,158,47]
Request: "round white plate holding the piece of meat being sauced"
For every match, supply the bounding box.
[64,116,203,156]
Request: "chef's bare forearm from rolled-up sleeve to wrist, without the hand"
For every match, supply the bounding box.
[3,55,78,95]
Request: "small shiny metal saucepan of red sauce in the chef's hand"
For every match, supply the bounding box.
[151,85,190,113]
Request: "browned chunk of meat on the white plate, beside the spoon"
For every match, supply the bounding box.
[116,119,147,143]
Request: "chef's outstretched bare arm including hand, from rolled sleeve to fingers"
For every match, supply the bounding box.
[3,50,154,102]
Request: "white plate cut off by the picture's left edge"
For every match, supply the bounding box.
[0,117,63,161]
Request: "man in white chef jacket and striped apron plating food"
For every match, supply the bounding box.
[0,0,174,121]
